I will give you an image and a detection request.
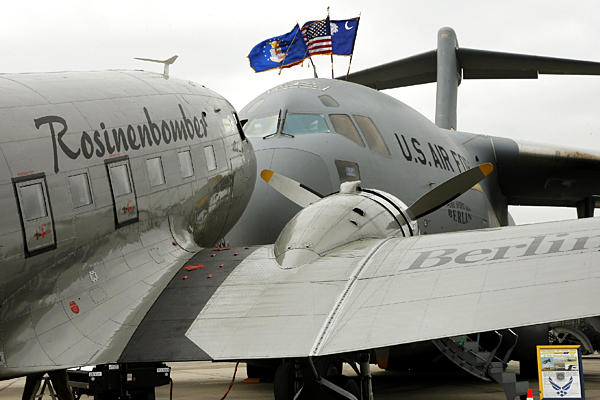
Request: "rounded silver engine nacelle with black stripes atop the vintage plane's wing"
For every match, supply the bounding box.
[275,181,419,268]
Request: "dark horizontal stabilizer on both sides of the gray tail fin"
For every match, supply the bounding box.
[337,48,600,90]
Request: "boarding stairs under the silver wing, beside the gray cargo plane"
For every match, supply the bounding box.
[432,330,529,400]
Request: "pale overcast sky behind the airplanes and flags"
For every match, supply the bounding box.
[0,0,600,223]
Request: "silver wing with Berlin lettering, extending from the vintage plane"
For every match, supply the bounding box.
[122,218,600,361]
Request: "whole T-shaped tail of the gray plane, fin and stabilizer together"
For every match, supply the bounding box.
[337,28,600,130]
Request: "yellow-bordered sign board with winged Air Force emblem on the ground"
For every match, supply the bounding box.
[537,346,585,400]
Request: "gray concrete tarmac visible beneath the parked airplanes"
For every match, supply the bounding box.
[0,356,600,400]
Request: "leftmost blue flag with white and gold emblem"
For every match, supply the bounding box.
[248,24,309,72]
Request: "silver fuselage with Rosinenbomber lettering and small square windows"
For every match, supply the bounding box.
[0,67,256,379]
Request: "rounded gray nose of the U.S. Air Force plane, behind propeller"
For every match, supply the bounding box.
[225,147,333,246]
